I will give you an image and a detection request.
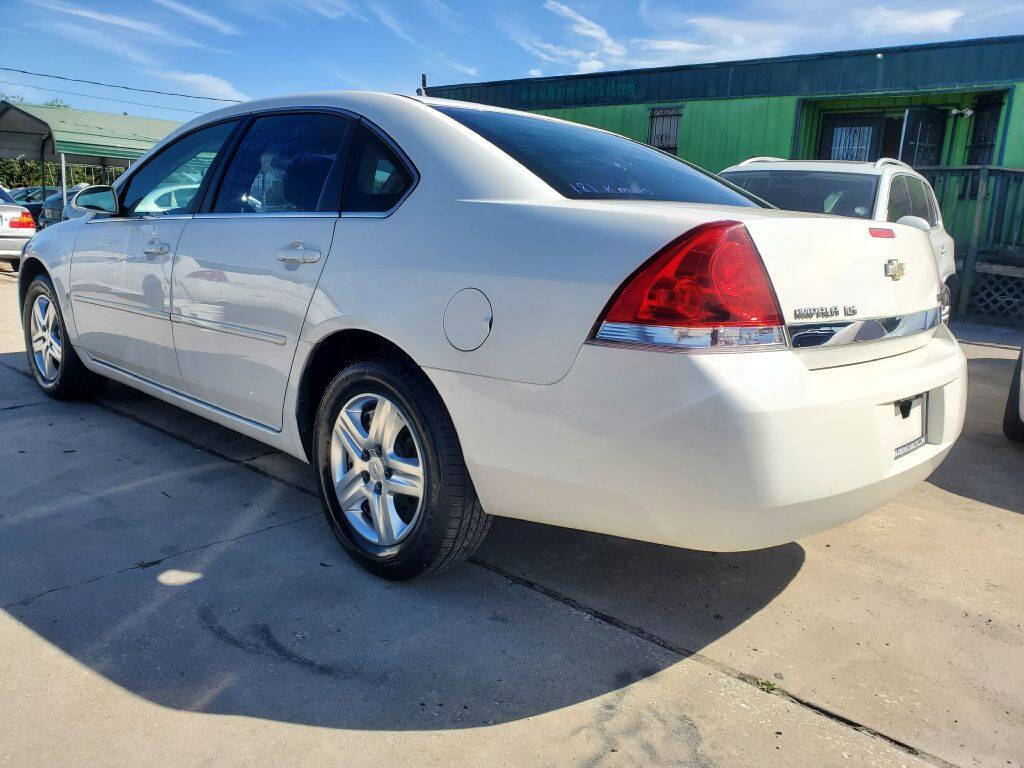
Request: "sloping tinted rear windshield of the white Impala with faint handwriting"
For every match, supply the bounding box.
[434,106,758,207]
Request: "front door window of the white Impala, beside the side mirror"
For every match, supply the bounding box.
[121,120,238,216]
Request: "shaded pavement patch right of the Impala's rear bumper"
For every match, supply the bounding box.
[929,357,1024,514]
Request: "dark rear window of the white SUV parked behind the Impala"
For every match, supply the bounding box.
[722,168,879,219]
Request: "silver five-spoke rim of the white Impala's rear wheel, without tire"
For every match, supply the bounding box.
[331,393,425,547]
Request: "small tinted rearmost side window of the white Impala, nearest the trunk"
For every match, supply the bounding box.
[341,125,413,213]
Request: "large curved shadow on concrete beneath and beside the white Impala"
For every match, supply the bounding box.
[0,354,804,730]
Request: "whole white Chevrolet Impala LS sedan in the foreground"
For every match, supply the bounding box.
[19,93,967,579]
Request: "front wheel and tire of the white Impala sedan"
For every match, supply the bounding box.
[22,274,106,400]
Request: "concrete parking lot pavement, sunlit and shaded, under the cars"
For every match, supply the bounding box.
[0,271,1024,767]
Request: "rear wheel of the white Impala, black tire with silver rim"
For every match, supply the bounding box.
[312,357,492,581]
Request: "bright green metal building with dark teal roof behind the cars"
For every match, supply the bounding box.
[427,36,1024,324]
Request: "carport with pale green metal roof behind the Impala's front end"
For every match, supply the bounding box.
[0,100,180,203]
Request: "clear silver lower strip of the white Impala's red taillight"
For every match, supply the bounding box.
[591,323,788,352]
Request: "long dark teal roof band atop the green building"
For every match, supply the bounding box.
[427,35,1024,110]
